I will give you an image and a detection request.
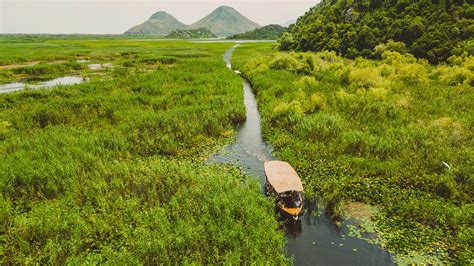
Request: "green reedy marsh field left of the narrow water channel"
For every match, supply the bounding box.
[0,37,286,264]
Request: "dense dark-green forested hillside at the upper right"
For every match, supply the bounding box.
[280,0,474,64]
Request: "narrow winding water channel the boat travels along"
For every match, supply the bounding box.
[213,44,394,265]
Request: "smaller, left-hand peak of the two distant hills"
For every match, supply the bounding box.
[125,11,187,35]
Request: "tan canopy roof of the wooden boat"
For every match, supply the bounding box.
[264,161,303,194]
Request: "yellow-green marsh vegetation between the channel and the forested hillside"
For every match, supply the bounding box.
[233,44,474,263]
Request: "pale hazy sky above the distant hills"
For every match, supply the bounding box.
[0,0,319,33]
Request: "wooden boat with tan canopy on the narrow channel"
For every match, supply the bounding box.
[264,161,303,220]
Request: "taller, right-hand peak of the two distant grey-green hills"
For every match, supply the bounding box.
[189,6,260,37]
